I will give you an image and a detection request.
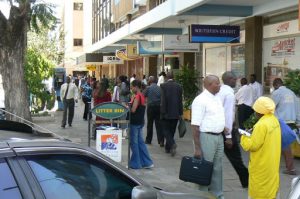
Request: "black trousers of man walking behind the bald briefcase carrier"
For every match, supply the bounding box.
[224,128,249,188]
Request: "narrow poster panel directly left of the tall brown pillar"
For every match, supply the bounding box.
[231,44,246,78]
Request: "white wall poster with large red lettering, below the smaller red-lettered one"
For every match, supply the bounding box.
[263,37,300,87]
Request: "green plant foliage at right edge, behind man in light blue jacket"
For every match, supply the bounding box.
[284,70,300,96]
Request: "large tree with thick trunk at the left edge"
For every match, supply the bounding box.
[0,0,56,120]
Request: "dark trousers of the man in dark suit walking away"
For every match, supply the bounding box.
[161,119,178,152]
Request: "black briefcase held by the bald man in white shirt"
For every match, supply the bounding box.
[179,156,213,186]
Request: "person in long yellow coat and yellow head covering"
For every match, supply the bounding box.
[241,97,281,199]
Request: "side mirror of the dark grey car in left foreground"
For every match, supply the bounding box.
[131,186,157,199]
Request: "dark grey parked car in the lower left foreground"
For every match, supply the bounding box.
[0,120,214,199]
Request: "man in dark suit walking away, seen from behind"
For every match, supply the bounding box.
[160,72,183,156]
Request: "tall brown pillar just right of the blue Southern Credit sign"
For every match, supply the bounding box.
[245,16,263,83]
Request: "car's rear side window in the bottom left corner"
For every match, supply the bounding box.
[0,159,22,199]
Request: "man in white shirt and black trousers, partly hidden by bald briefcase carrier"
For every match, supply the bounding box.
[217,71,249,188]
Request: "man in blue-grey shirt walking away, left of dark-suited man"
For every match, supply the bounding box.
[144,76,164,147]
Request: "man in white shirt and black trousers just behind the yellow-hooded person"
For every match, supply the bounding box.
[235,78,254,129]
